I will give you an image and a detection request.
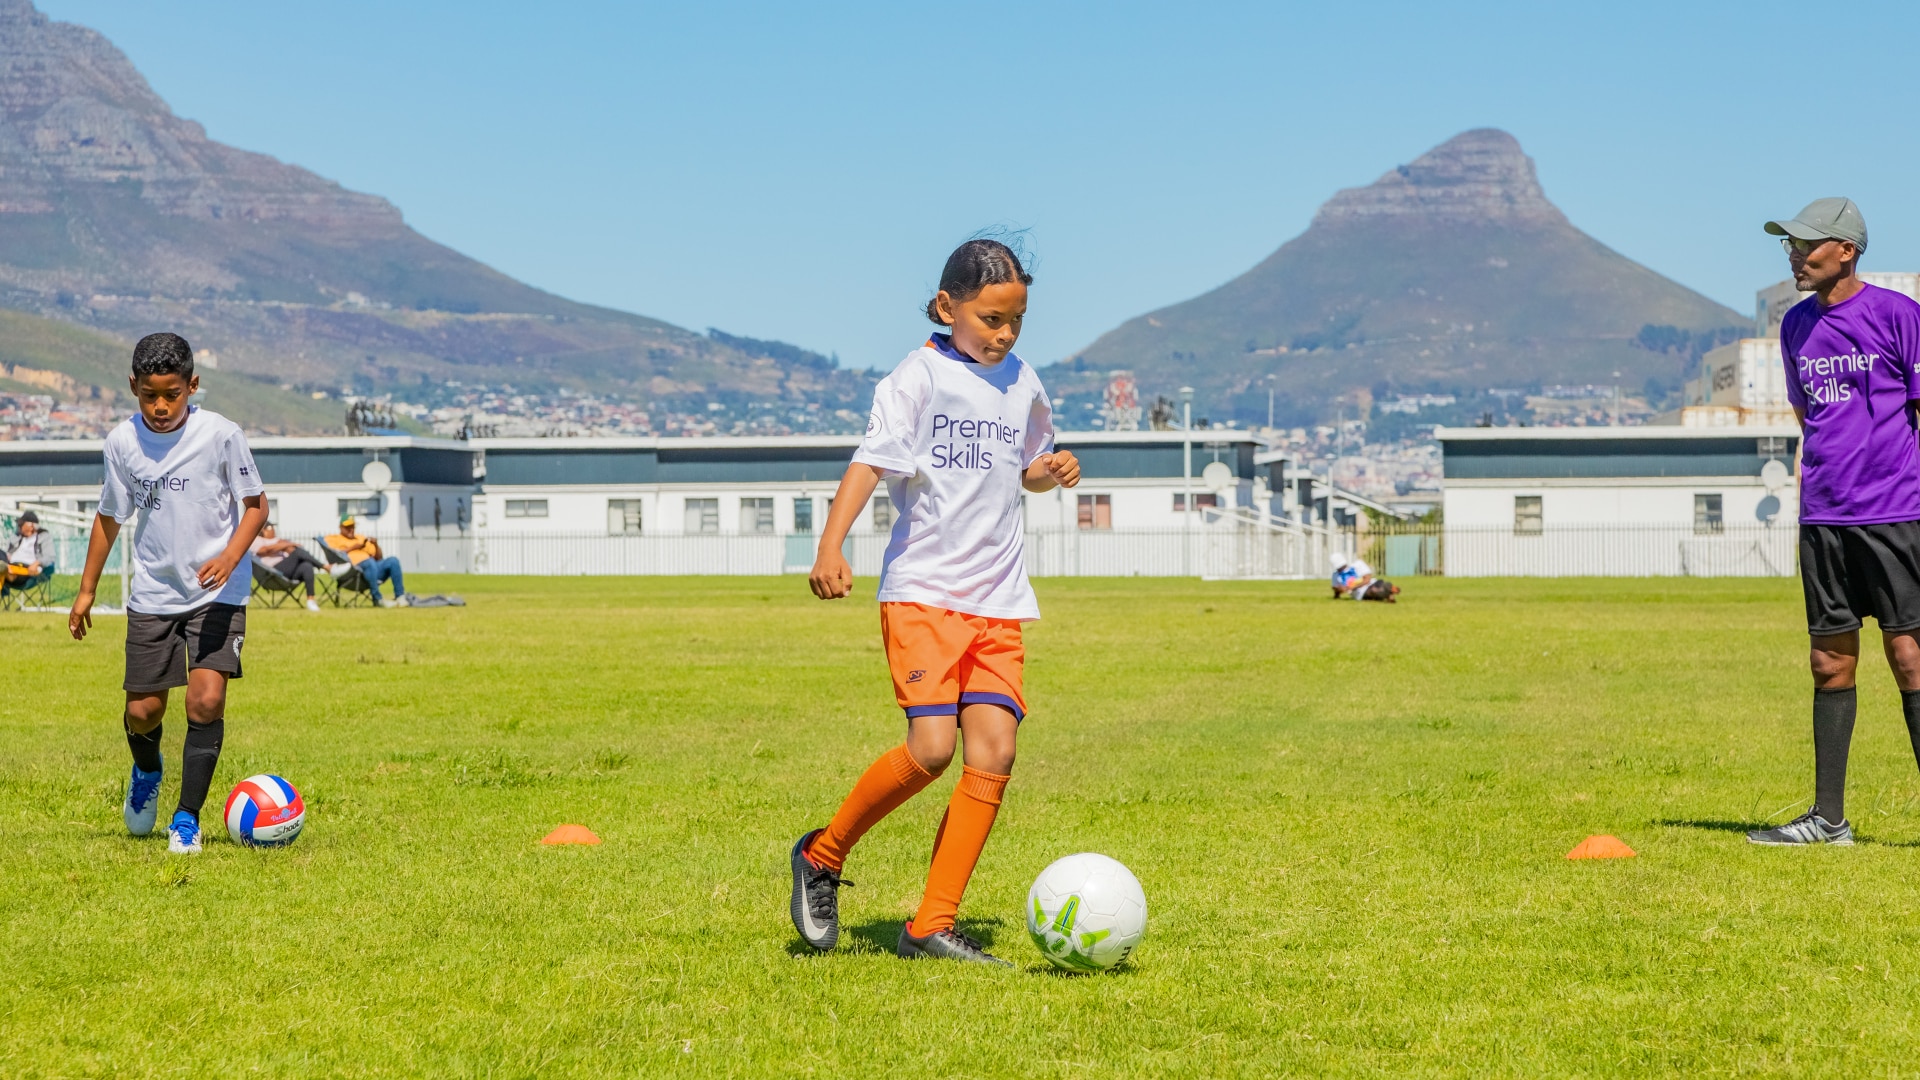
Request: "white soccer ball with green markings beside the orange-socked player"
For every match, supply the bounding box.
[1027,851,1146,970]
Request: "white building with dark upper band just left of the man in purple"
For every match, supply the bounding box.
[1434,427,1801,577]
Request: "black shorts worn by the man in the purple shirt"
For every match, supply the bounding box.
[1801,521,1920,638]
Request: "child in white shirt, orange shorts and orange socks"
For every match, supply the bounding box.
[791,240,1079,965]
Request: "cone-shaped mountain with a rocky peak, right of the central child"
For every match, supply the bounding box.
[1048,129,1749,423]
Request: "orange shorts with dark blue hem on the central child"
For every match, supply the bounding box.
[879,603,1027,721]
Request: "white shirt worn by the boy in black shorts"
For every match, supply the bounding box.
[100,405,265,615]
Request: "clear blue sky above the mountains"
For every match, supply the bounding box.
[40,0,1920,367]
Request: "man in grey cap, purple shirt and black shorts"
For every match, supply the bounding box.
[1747,198,1920,844]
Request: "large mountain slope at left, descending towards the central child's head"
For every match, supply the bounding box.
[0,0,872,428]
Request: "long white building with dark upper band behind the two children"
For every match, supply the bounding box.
[11,430,1279,575]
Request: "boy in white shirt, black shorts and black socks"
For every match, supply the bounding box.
[67,334,267,853]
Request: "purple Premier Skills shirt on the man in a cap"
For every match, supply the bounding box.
[1780,284,1920,525]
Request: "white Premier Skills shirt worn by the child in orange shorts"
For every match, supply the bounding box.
[852,334,1054,619]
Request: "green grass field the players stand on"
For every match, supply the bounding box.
[0,578,1920,1078]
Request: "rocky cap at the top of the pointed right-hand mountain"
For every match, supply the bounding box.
[1313,127,1567,225]
